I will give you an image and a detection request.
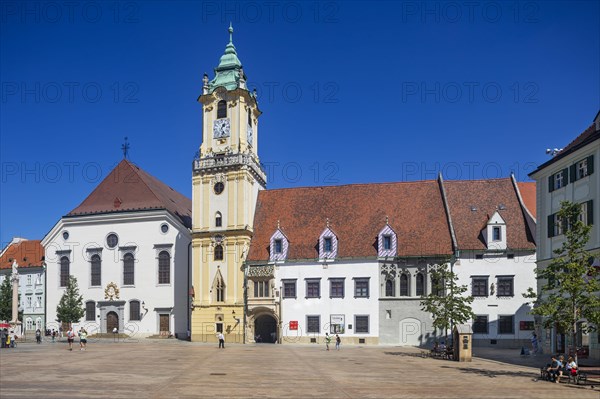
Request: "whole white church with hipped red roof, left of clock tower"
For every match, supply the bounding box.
[42,159,191,338]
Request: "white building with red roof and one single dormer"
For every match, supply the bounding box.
[443,177,537,347]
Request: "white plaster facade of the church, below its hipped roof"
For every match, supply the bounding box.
[43,210,191,338]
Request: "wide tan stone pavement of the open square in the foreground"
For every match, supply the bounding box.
[0,340,600,399]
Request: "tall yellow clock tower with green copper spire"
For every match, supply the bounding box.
[190,26,266,342]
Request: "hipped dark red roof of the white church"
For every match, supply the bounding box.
[67,159,192,228]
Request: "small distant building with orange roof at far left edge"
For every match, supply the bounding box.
[0,238,46,337]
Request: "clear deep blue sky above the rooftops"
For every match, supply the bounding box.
[0,1,600,246]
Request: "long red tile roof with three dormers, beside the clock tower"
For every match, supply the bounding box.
[247,180,452,261]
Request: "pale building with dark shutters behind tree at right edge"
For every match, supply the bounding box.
[530,112,600,359]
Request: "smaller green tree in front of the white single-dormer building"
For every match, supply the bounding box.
[421,263,475,344]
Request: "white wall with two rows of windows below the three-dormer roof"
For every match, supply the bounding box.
[275,260,379,344]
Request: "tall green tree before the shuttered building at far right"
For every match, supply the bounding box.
[523,201,600,360]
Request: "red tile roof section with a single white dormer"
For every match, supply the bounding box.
[444,178,535,250]
